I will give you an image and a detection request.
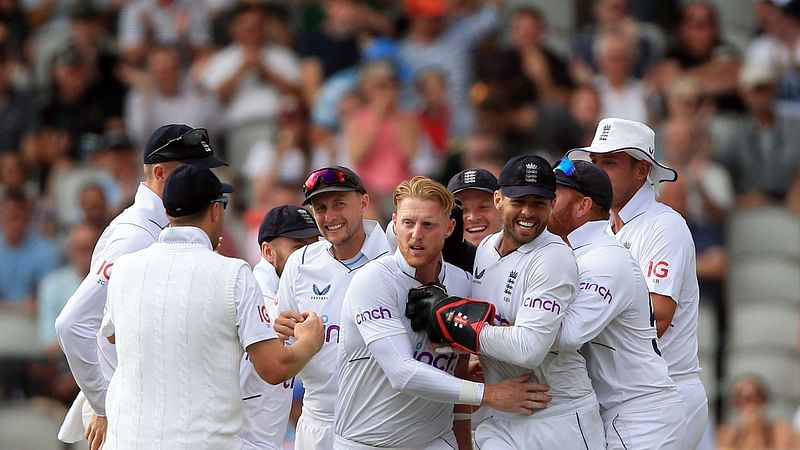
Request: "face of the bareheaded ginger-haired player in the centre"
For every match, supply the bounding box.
[392,198,455,270]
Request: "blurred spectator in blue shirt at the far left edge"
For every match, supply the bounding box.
[0,192,61,314]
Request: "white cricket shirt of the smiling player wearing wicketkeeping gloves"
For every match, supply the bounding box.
[472,230,596,418]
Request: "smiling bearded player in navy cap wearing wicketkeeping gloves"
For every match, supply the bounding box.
[472,155,605,450]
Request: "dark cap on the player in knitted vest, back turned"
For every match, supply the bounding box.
[161,164,233,217]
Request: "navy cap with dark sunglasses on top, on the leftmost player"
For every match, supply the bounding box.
[144,124,228,169]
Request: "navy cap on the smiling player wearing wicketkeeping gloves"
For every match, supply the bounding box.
[500,155,556,199]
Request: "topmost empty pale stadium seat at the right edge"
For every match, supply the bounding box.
[728,207,800,262]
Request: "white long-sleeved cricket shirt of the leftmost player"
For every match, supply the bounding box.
[56,183,169,415]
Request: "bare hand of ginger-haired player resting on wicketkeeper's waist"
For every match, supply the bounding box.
[481,375,552,416]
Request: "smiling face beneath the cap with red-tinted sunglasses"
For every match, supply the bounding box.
[311,191,369,259]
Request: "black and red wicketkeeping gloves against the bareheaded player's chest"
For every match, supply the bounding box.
[406,284,495,353]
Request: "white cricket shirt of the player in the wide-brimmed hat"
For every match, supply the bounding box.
[608,183,700,380]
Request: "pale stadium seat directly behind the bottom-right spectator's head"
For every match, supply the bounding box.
[727,351,800,405]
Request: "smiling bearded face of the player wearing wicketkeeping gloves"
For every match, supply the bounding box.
[494,191,553,254]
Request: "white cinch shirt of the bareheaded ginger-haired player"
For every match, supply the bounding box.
[335,250,470,448]
